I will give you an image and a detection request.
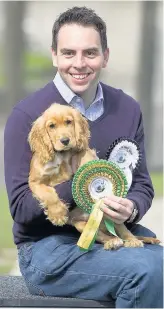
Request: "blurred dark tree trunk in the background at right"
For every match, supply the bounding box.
[137,1,159,168]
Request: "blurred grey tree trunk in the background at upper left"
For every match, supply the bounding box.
[4,1,26,110]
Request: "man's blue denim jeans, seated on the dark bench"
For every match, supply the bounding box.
[18,224,163,308]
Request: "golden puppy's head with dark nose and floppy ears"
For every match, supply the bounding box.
[28,103,90,163]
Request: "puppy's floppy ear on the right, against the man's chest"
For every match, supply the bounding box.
[73,109,90,151]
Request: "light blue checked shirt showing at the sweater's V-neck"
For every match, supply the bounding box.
[54,73,104,121]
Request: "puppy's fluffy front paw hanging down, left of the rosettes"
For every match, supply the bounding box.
[46,202,68,226]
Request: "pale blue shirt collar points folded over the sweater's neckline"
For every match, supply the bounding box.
[53,72,104,104]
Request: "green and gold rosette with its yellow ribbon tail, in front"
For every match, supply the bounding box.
[72,160,128,250]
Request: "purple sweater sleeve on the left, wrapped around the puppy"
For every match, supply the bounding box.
[4,108,72,224]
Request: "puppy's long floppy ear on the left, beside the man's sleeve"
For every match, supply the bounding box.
[28,116,54,164]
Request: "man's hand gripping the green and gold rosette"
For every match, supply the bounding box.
[100,195,134,224]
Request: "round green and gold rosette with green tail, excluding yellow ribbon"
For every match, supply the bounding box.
[72,160,128,248]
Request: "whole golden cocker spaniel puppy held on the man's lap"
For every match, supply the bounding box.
[28,103,159,249]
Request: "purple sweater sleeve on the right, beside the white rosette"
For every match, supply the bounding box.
[127,108,154,222]
